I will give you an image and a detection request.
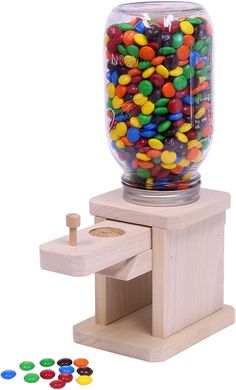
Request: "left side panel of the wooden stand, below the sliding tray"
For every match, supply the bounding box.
[95,272,152,325]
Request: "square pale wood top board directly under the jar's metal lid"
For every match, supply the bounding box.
[90,189,230,229]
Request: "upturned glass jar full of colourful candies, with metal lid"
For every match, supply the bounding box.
[105,1,213,206]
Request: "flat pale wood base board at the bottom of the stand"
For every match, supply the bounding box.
[73,305,235,362]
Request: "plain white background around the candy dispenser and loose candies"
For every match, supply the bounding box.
[0,0,236,390]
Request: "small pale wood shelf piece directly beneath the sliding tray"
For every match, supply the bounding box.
[99,249,152,281]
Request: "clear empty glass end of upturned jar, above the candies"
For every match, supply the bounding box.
[112,1,205,16]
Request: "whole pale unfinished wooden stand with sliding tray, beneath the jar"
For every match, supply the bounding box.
[40,189,234,361]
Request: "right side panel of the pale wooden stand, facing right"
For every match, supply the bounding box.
[152,213,225,338]
